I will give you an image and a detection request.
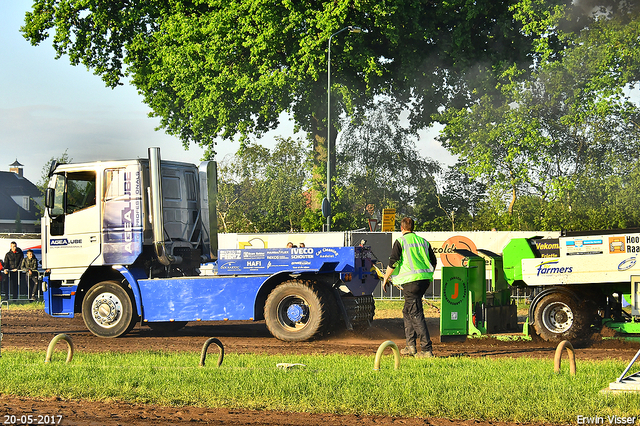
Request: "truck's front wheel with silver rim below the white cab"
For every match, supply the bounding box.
[82,281,137,337]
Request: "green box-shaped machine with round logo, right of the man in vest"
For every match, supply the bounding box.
[440,250,518,342]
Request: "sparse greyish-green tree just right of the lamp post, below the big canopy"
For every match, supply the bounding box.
[334,98,440,229]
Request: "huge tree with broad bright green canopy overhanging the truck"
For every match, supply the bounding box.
[21,0,532,200]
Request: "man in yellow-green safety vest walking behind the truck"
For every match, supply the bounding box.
[382,217,437,358]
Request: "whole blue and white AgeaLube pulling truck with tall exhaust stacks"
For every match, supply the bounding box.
[42,148,379,341]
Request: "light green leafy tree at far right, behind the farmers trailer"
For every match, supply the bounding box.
[439,2,640,229]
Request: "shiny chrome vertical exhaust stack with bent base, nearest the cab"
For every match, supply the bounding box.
[149,147,182,266]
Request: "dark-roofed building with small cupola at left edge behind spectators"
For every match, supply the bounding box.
[0,159,42,234]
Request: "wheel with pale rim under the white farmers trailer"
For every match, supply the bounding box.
[534,293,589,342]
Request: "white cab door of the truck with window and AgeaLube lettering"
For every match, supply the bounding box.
[45,170,100,269]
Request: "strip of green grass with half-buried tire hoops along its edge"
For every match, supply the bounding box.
[0,347,640,423]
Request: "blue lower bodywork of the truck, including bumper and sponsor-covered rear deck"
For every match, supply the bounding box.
[44,247,379,322]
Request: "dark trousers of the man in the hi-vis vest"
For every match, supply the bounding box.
[402,280,432,351]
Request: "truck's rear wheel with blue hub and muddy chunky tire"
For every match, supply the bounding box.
[264,280,335,342]
